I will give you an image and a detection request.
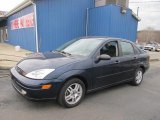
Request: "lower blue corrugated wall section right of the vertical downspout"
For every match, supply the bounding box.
[88,5,138,42]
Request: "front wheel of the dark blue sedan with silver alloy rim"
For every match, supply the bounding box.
[58,78,86,108]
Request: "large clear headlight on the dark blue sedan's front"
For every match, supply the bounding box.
[25,69,55,79]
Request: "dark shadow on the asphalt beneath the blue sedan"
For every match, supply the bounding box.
[19,83,130,110]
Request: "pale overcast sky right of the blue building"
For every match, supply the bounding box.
[129,0,160,30]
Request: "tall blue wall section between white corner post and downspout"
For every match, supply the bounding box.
[36,0,94,51]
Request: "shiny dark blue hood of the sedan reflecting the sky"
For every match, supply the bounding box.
[17,52,79,73]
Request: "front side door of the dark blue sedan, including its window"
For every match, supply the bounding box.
[93,40,121,88]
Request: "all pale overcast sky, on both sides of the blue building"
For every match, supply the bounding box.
[0,0,160,30]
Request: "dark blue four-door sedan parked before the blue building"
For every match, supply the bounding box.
[11,37,149,107]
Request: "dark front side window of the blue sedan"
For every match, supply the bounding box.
[100,41,118,57]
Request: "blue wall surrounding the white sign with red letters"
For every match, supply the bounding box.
[7,6,36,51]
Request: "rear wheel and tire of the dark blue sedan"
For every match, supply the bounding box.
[131,68,143,86]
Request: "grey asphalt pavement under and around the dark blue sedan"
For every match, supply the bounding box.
[0,62,160,120]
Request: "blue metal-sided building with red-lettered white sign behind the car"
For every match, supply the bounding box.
[0,0,139,52]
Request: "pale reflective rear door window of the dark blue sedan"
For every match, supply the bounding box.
[121,42,134,56]
